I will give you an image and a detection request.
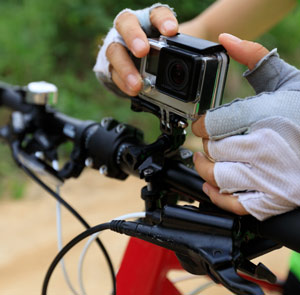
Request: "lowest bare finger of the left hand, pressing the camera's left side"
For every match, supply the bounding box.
[106,43,142,96]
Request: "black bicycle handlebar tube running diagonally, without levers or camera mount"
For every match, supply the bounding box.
[0,88,300,247]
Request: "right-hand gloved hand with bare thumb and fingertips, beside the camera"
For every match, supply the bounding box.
[193,34,300,220]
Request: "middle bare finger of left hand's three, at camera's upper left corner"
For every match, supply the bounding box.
[115,12,150,58]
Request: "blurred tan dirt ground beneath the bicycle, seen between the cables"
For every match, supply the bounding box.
[0,171,289,295]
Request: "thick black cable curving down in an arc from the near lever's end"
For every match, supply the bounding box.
[42,222,110,295]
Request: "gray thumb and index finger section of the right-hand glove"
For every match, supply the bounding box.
[205,50,300,139]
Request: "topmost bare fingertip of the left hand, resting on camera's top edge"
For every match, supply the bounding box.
[150,7,178,36]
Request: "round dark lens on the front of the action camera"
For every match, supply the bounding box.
[167,60,189,90]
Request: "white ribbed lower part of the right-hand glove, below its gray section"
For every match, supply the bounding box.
[208,118,300,220]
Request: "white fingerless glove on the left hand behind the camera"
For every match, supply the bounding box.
[93,3,176,88]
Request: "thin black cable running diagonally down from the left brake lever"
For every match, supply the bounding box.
[18,162,117,295]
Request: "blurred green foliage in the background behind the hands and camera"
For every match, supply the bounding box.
[0,0,300,199]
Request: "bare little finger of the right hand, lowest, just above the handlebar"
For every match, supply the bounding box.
[203,183,249,215]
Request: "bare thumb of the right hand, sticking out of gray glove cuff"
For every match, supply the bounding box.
[219,33,269,70]
